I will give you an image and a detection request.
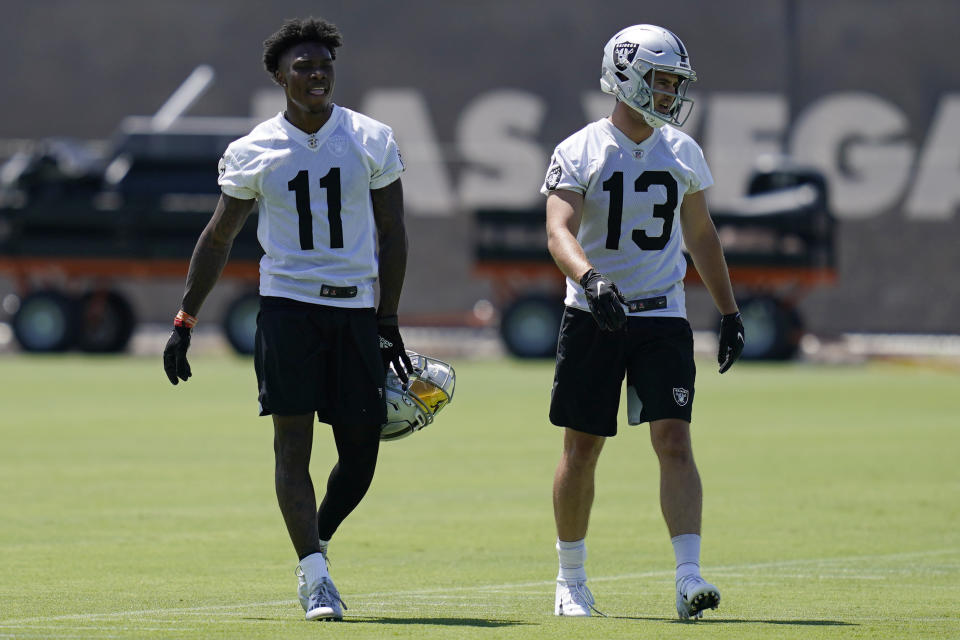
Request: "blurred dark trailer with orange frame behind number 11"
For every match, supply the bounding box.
[0,66,262,353]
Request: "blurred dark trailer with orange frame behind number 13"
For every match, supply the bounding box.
[474,161,837,360]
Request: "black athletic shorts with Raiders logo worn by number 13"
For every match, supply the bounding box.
[550,307,697,436]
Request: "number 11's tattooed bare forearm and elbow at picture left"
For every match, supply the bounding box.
[180,194,256,316]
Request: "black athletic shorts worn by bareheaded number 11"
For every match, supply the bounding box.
[254,296,387,425]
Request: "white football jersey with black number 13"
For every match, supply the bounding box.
[540,118,713,317]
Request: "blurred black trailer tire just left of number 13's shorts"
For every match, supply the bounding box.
[500,294,563,358]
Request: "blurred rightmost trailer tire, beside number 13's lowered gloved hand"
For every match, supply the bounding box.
[738,296,803,360]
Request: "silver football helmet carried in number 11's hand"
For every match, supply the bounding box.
[380,349,457,440]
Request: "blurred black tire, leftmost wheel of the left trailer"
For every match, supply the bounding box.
[12,291,77,353]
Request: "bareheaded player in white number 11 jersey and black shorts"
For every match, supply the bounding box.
[163,18,411,620]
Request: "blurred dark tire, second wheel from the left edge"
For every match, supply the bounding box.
[77,291,137,353]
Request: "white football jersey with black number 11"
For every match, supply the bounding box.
[218,105,403,307]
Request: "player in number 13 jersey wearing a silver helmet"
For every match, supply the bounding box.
[541,24,744,619]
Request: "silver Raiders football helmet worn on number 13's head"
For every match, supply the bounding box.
[600,24,697,127]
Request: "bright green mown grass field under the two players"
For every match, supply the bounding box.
[0,356,960,640]
